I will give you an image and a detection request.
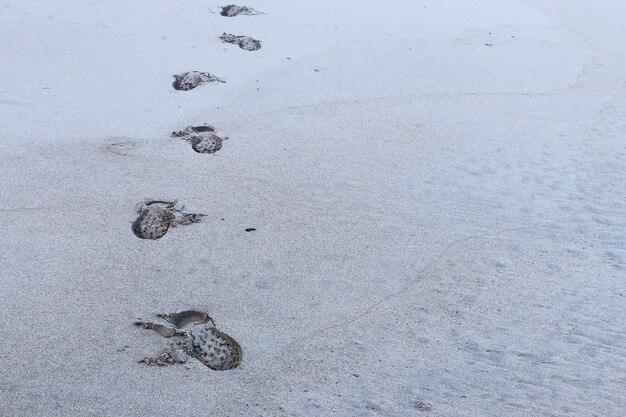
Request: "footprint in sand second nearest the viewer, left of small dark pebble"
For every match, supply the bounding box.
[131,200,205,240]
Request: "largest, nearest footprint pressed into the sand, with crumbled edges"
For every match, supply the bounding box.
[135,310,243,371]
